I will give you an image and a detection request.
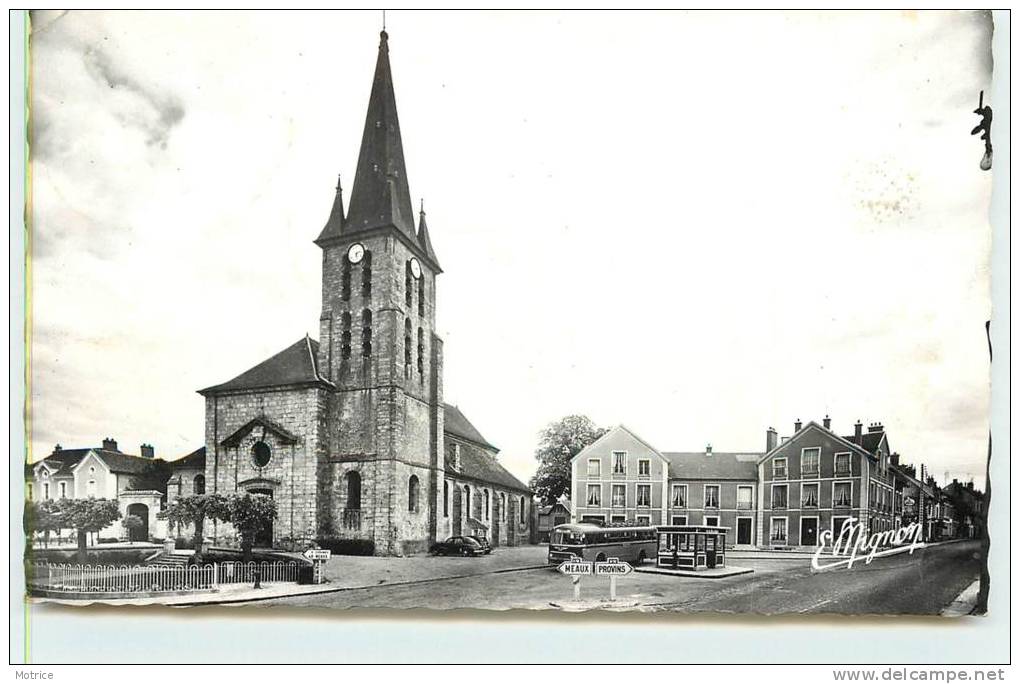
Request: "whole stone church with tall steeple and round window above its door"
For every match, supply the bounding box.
[193,31,533,556]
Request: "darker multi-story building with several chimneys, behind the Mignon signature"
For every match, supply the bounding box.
[757,417,896,547]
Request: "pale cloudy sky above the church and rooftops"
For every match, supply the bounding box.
[29,11,991,485]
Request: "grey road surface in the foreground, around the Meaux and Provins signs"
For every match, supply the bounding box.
[246,541,980,615]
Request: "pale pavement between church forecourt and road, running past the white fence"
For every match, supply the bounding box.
[33,545,548,607]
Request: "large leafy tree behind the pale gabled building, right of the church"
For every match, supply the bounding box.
[530,416,608,505]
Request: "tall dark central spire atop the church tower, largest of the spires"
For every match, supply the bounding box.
[345,31,414,239]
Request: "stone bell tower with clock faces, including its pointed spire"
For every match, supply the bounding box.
[315,31,444,555]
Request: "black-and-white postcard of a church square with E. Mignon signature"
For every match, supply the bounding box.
[24,11,991,619]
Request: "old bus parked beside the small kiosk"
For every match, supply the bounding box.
[549,523,656,565]
